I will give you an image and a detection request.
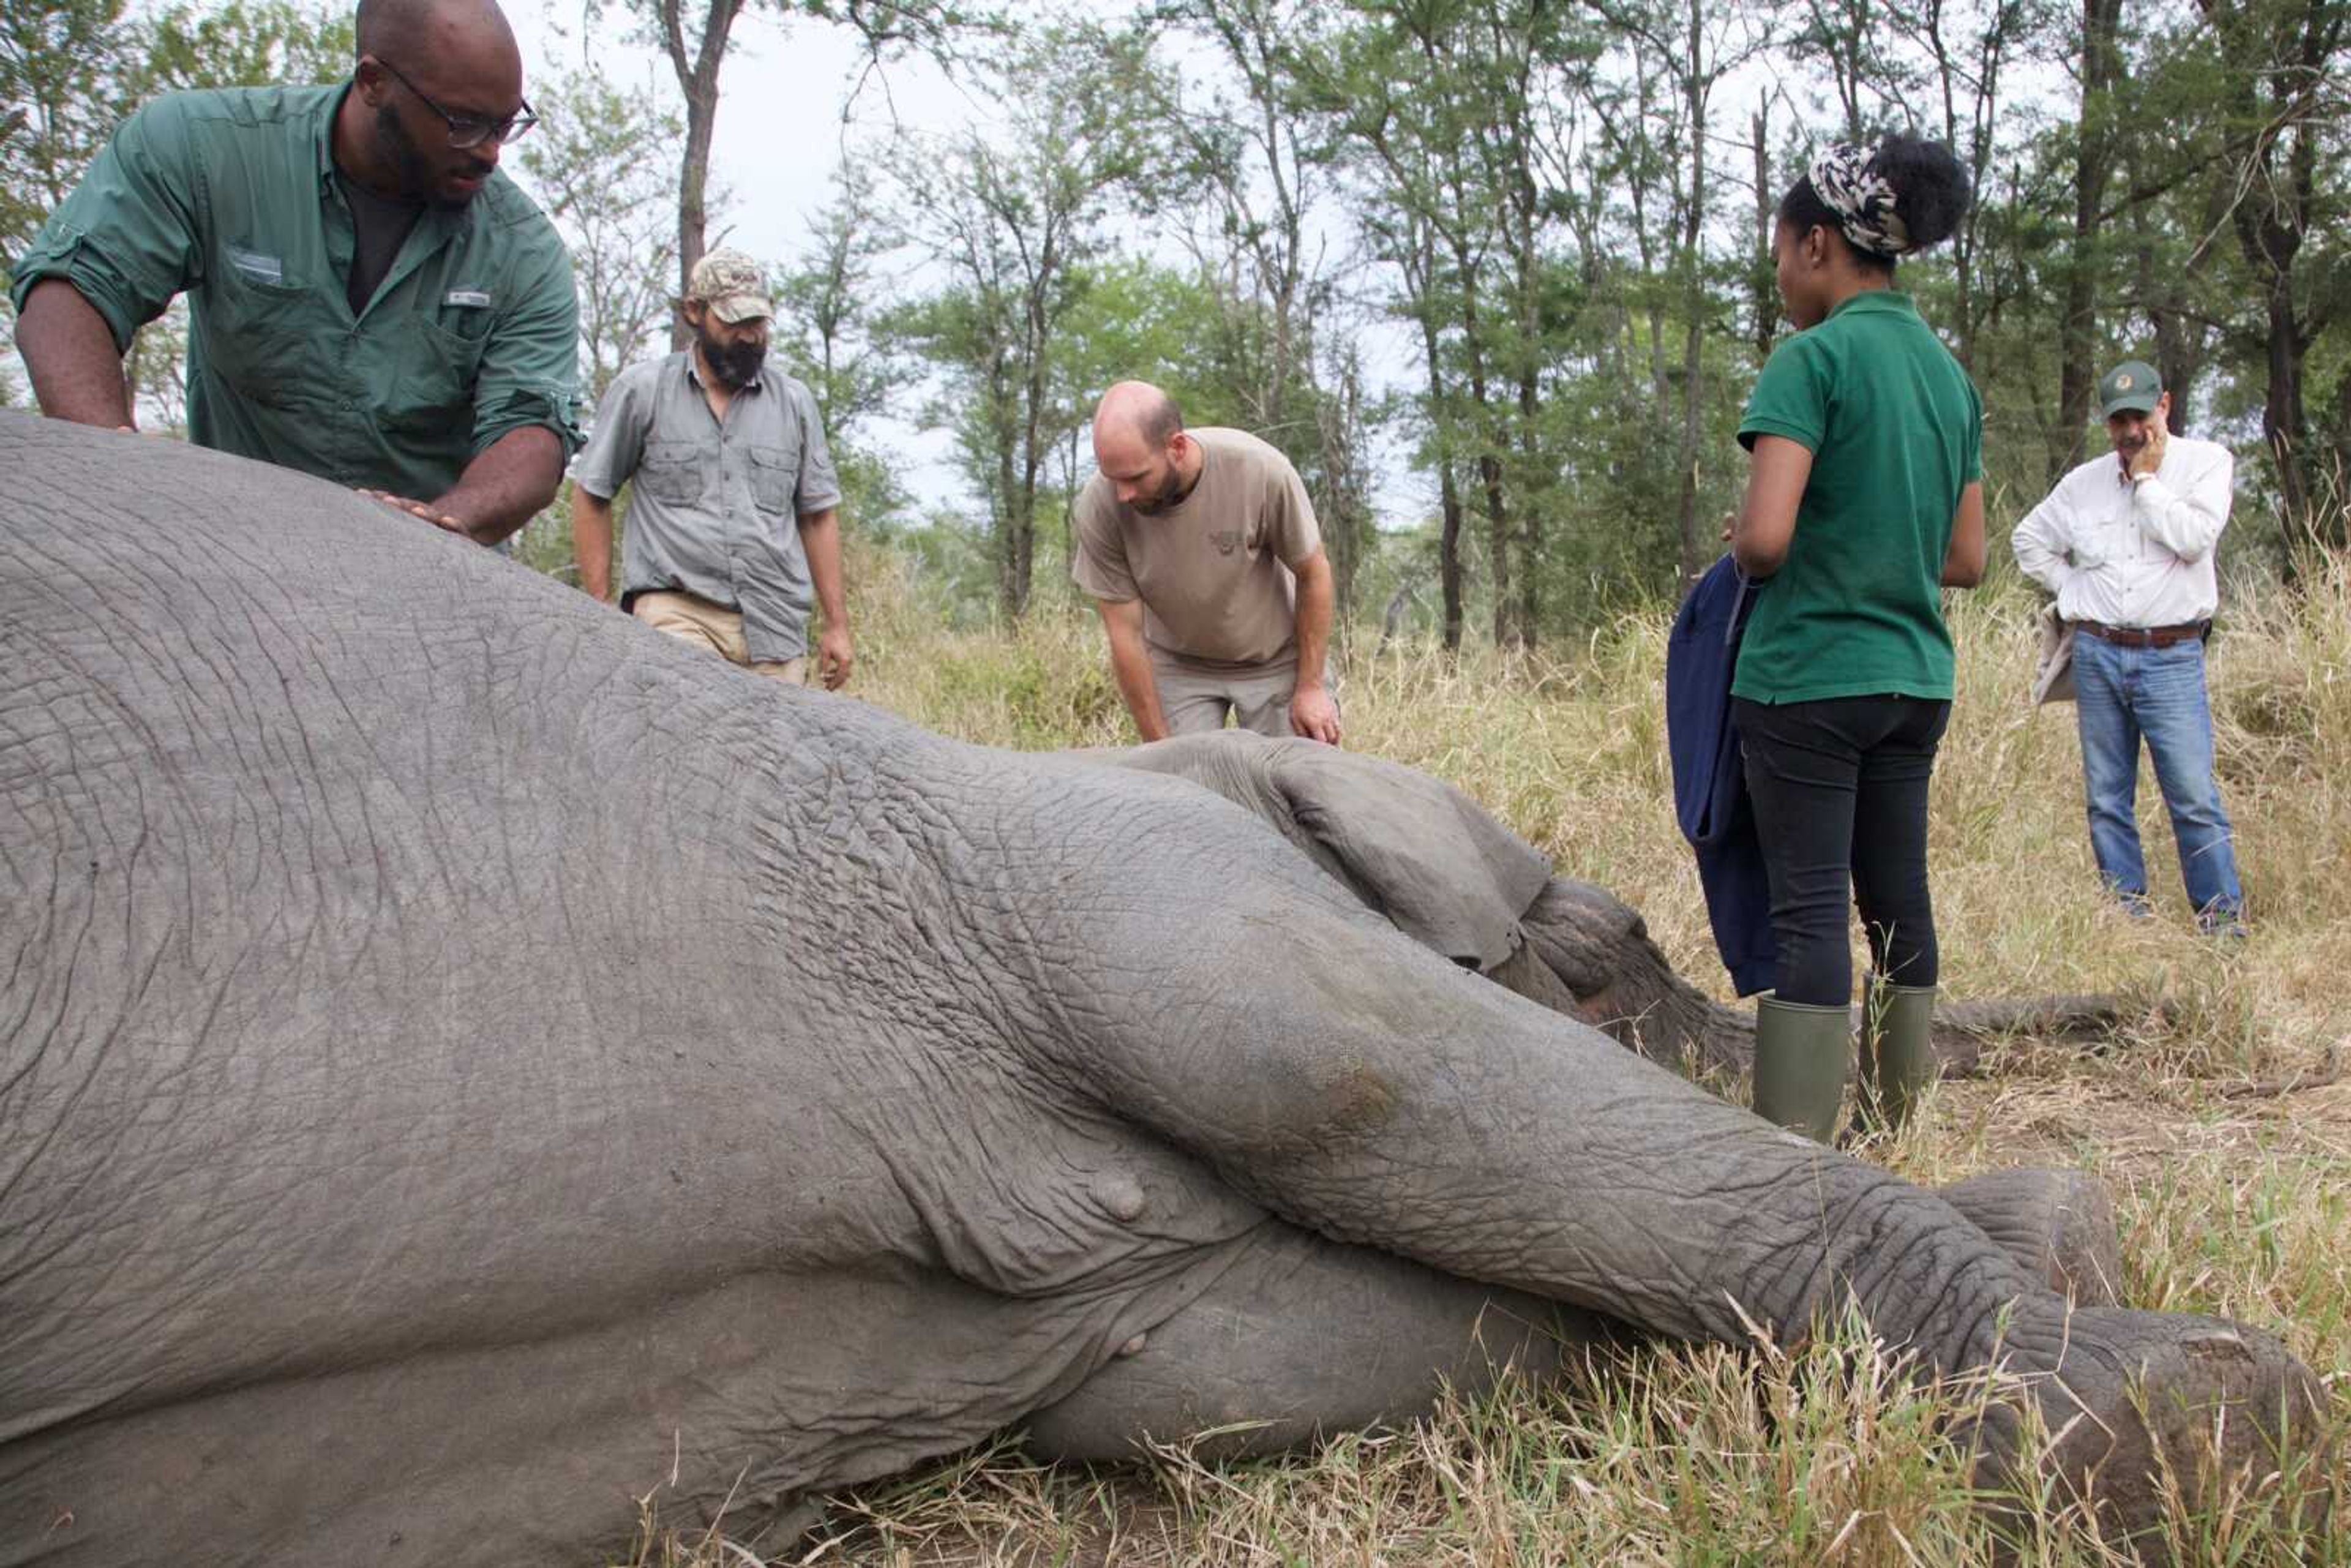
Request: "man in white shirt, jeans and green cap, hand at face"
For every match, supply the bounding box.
[2012,359,2245,933]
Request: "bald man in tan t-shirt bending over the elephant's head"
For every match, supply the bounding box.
[1070,381,1340,745]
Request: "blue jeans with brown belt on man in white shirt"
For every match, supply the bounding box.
[2074,632,2245,926]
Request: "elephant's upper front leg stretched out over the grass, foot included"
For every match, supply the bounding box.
[1056,893,2325,1531]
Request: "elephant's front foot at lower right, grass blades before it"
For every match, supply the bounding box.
[1961,1302,2330,1563]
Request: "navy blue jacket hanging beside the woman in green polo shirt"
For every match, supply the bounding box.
[1665,555,1780,997]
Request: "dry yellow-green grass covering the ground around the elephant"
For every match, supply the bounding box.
[611,560,2351,1568]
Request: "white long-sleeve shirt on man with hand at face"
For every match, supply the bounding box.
[2010,435,2236,628]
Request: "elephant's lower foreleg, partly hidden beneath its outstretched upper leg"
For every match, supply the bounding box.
[1027,1220,1634,1462]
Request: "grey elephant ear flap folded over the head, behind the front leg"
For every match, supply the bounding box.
[1265,740,1551,973]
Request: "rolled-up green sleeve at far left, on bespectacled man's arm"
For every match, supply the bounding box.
[9,96,204,353]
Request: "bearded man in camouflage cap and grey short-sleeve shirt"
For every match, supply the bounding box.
[571,249,853,689]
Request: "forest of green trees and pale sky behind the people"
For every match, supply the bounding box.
[0,0,2351,649]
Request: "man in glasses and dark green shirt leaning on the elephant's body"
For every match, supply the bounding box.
[14,0,579,543]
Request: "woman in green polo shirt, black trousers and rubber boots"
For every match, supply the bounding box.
[1730,137,1984,1140]
